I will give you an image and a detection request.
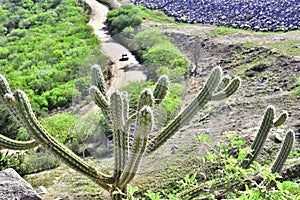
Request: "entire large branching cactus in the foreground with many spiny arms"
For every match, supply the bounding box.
[0,65,240,199]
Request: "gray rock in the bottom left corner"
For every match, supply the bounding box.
[0,168,42,200]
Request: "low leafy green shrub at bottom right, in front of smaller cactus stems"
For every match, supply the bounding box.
[129,126,300,200]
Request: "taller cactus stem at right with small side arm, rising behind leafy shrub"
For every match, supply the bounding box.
[241,106,274,168]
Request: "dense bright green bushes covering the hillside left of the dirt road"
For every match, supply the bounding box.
[0,0,108,114]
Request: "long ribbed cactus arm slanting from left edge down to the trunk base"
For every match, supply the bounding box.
[4,90,112,189]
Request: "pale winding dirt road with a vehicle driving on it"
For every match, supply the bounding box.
[85,0,147,91]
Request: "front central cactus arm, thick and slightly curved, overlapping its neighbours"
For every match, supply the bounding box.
[119,106,153,188]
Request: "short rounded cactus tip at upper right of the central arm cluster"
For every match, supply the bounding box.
[153,75,170,104]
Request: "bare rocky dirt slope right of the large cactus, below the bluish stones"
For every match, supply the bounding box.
[129,24,300,194]
